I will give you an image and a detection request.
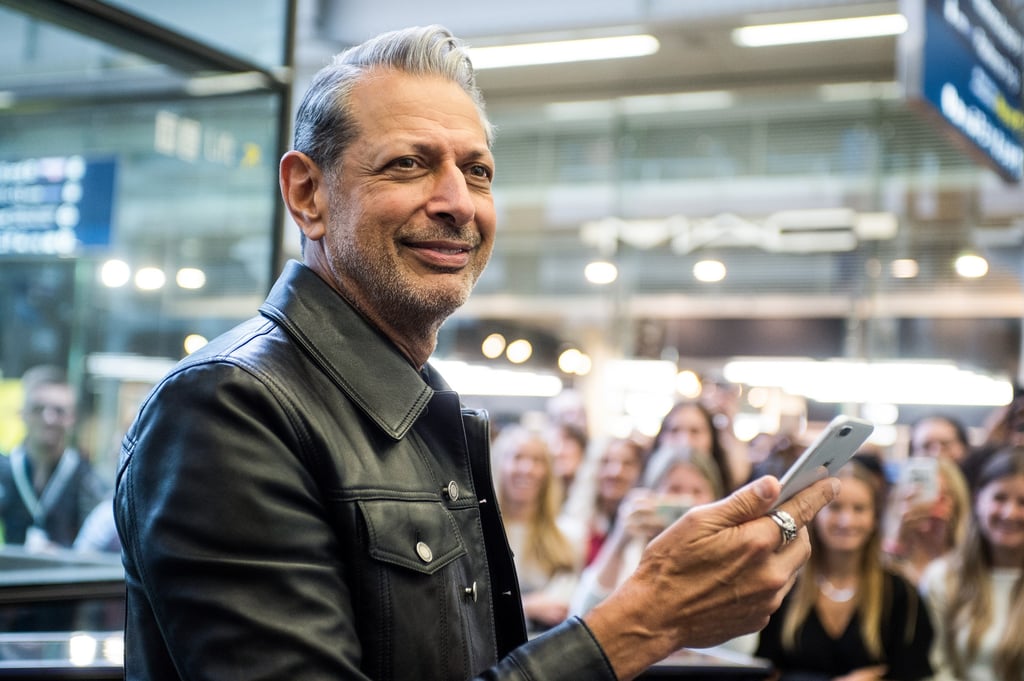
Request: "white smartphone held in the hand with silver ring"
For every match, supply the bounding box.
[773,416,874,508]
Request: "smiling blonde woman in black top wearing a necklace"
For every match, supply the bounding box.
[756,460,933,681]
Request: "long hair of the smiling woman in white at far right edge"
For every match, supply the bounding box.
[940,446,1024,681]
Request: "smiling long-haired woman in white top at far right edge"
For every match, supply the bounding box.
[923,446,1024,681]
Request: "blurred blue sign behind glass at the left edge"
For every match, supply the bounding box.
[0,156,117,256]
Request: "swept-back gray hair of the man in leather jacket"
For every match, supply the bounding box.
[294,26,494,173]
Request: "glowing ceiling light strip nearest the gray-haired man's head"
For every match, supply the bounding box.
[469,35,660,71]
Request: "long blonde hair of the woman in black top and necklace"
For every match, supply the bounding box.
[781,460,919,662]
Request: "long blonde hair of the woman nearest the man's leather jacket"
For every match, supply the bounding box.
[490,425,579,576]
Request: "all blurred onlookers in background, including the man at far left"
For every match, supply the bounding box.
[6,360,1024,681]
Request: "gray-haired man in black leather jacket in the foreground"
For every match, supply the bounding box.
[115,27,837,681]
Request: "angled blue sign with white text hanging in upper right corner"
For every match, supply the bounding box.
[903,0,1024,181]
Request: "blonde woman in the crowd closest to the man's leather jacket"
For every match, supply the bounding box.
[492,426,581,633]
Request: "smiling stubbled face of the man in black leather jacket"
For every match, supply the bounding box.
[323,71,496,328]
